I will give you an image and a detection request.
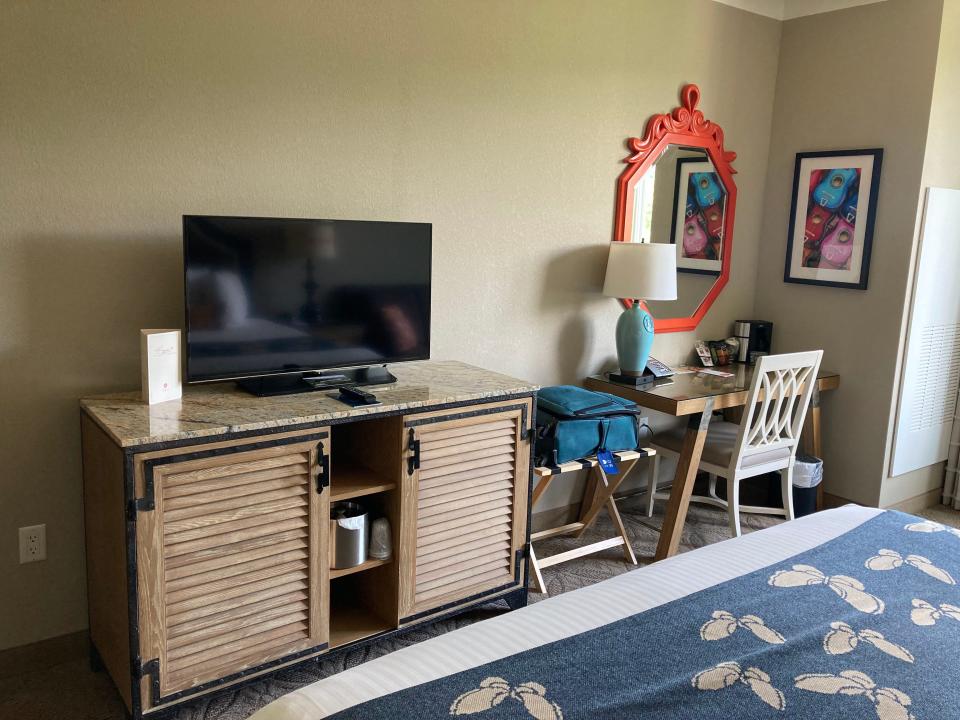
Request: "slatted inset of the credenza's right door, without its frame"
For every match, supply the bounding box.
[415,418,517,607]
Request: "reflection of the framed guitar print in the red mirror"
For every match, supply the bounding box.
[670,157,727,275]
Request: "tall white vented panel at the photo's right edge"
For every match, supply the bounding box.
[890,188,960,475]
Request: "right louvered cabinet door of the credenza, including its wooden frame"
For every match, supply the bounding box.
[401,399,531,616]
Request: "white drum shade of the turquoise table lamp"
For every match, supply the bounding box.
[603,242,677,300]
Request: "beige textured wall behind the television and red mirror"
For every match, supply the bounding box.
[0,0,780,648]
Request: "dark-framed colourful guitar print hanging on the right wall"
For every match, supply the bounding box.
[783,149,883,290]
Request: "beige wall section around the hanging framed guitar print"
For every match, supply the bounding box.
[756,0,942,505]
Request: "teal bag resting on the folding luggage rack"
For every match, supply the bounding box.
[534,385,641,465]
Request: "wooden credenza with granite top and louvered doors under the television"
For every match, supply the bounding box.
[81,362,537,717]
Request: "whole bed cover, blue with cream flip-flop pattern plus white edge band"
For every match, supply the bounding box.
[256,508,960,720]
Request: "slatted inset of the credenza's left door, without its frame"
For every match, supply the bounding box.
[158,450,316,694]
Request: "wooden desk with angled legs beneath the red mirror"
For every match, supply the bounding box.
[584,364,840,560]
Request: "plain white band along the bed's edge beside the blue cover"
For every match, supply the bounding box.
[252,505,883,720]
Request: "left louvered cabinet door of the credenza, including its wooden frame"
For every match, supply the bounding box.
[136,432,329,707]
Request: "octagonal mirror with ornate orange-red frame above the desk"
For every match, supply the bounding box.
[613,85,737,333]
